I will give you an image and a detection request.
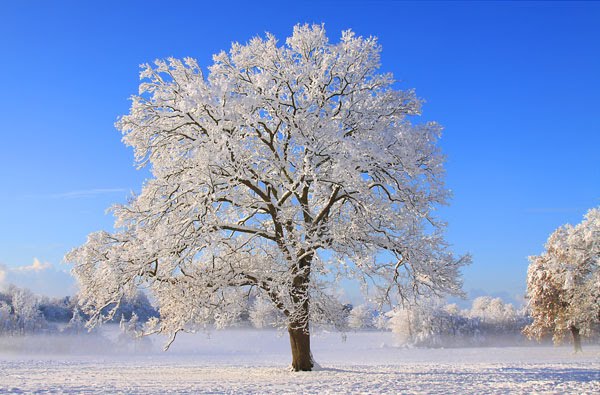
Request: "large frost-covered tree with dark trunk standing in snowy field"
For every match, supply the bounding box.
[66,25,468,370]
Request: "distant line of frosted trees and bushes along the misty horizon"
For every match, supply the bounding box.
[0,285,593,347]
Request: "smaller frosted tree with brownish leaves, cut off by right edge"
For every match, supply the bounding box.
[525,208,600,351]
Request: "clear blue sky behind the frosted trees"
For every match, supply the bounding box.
[0,1,600,299]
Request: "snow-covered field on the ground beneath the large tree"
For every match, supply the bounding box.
[0,329,600,394]
